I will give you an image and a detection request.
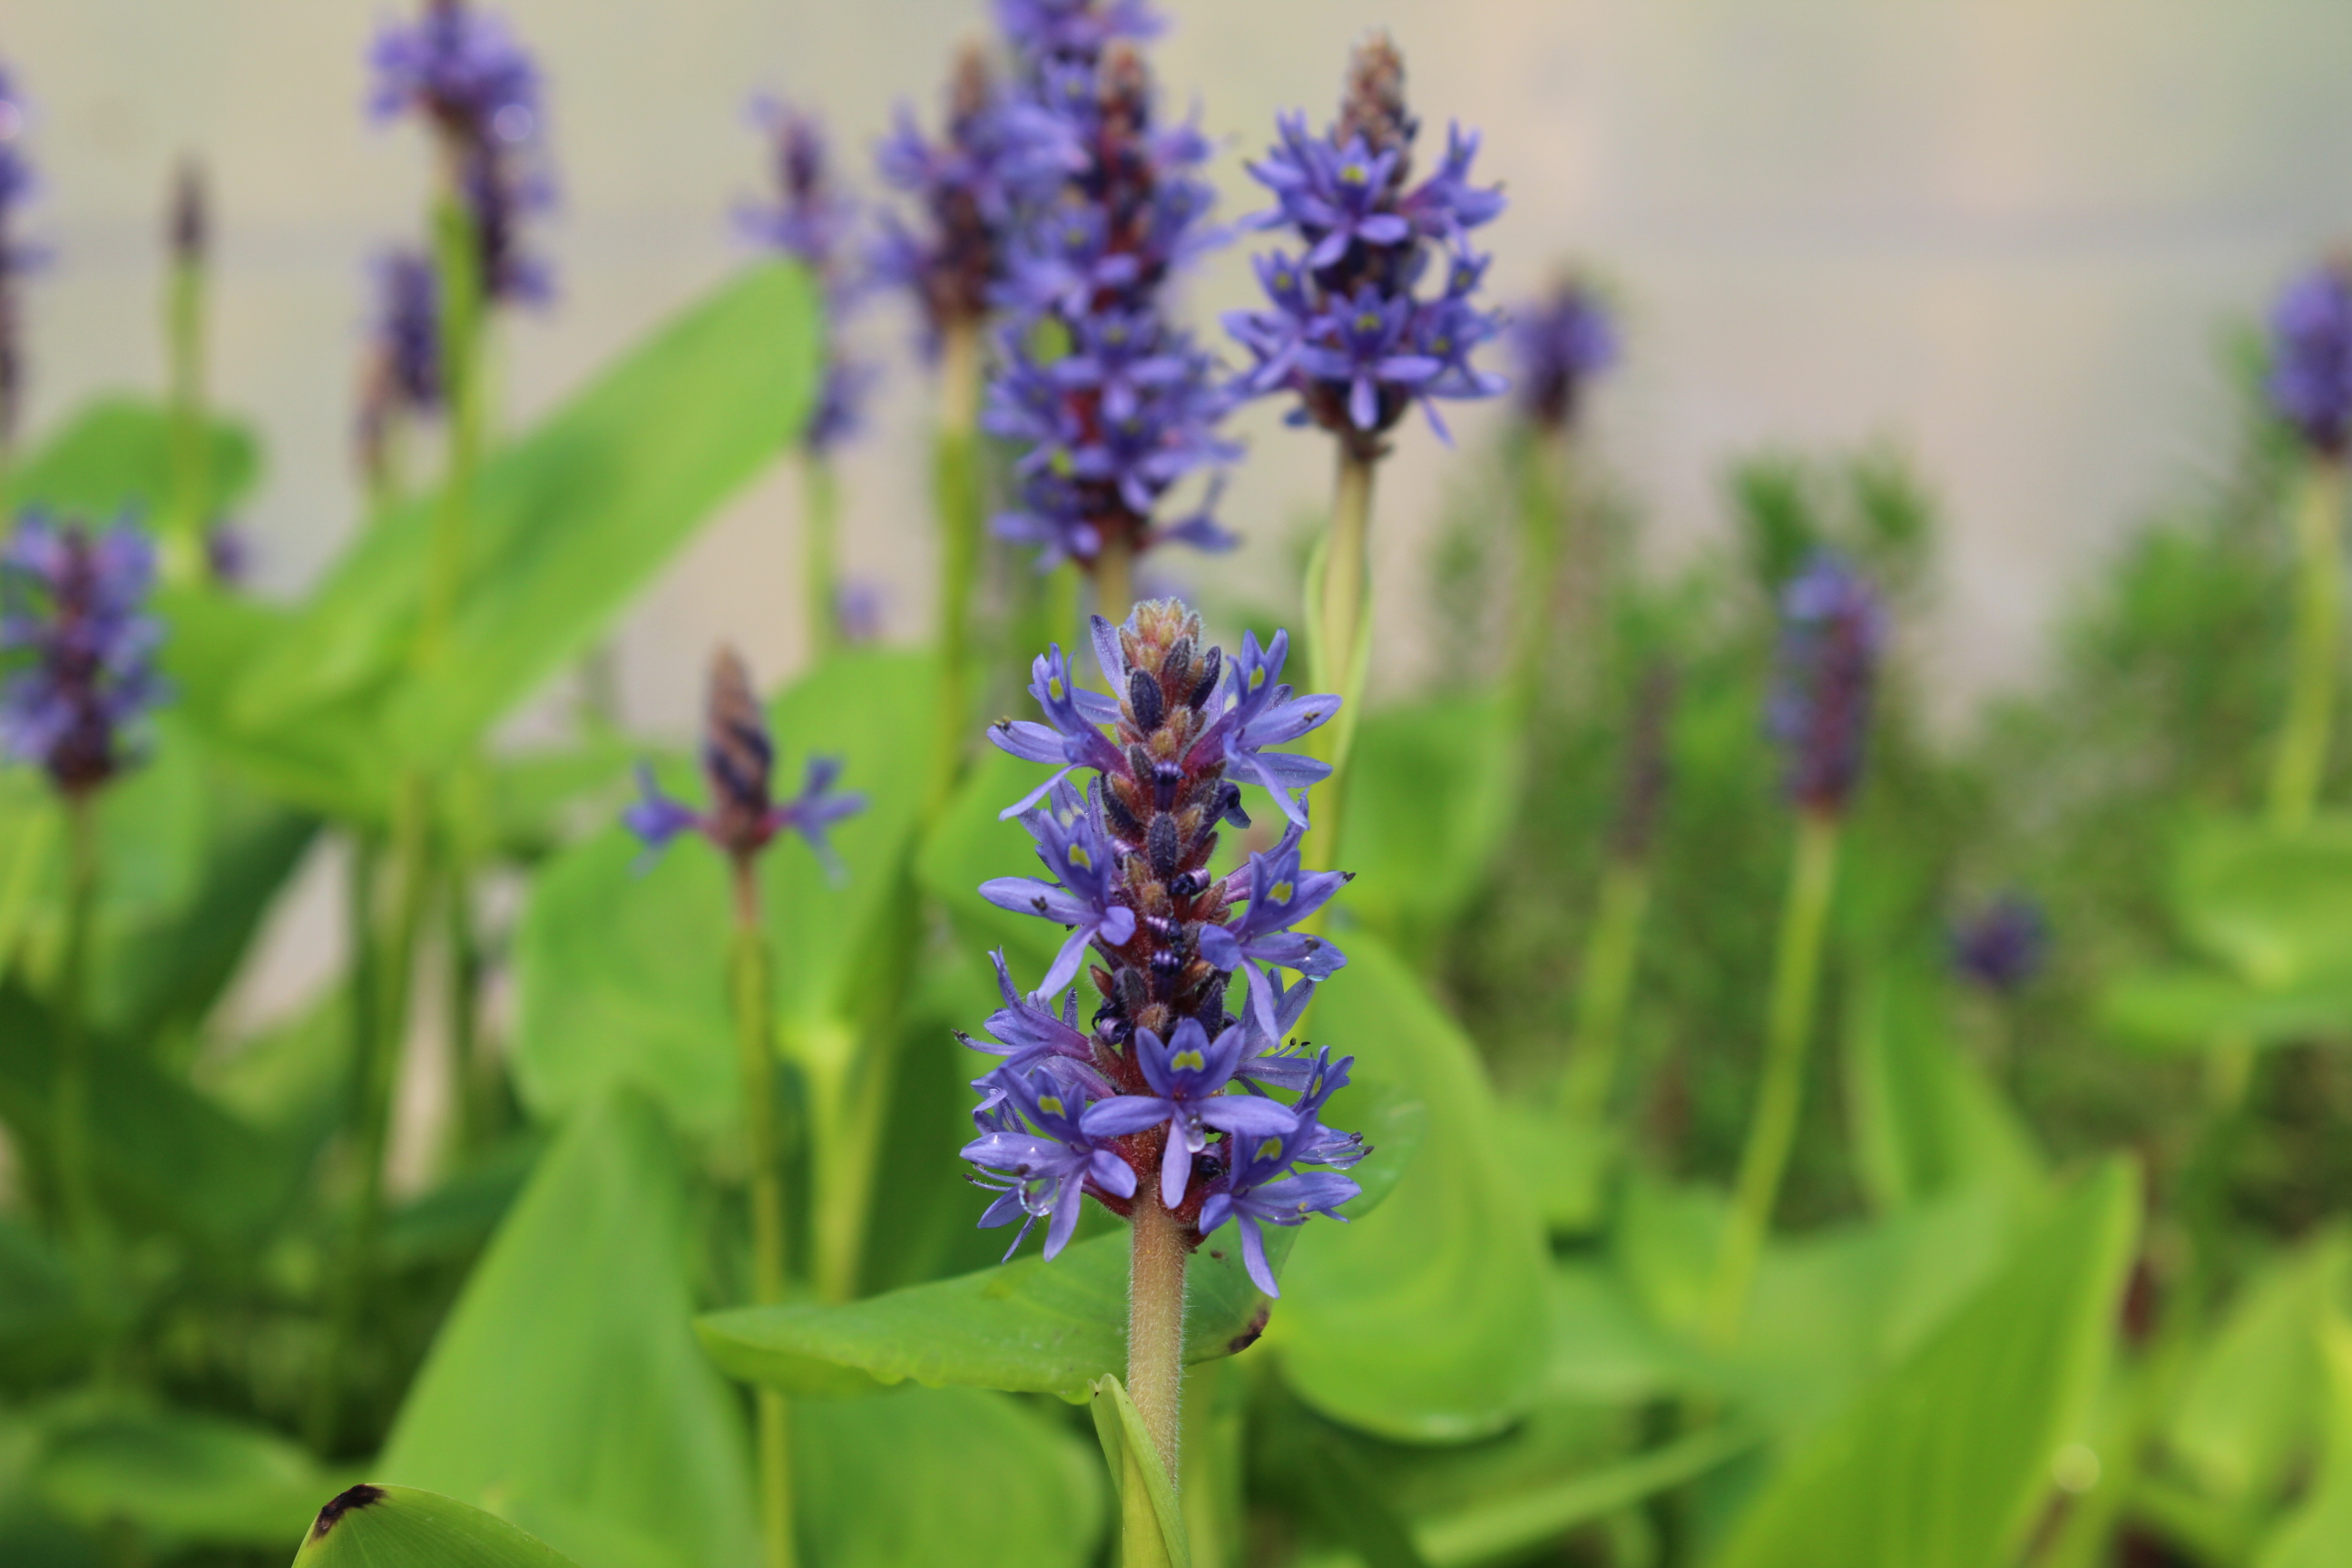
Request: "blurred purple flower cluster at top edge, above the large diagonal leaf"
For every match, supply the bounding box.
[369,0,555,301]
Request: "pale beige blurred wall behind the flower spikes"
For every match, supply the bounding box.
[0,0,2352,727]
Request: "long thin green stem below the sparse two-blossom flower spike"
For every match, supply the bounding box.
[731,856,798,1568]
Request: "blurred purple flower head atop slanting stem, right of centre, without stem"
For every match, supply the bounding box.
[1767,550,1886,816]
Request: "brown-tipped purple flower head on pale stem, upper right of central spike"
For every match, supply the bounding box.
[1225,37,1505,461]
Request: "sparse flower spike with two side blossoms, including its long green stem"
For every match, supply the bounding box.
[623,649,863,1568]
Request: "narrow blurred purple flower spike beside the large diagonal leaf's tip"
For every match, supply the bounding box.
[739,94,877,456]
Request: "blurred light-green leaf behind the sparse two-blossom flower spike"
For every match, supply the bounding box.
[515,652,931,1135]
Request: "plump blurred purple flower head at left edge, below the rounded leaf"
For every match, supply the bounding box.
[0,513,162,797]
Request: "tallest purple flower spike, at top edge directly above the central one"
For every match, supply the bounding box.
[983,18,1240,572]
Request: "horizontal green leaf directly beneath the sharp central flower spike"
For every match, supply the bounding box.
[699,1227,1294,1401]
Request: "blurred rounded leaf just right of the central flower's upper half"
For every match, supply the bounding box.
[1340,693,1514,950]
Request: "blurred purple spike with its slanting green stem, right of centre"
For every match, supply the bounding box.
[1708,554,1886,1345]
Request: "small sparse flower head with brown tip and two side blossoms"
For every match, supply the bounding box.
[621,646,866,882]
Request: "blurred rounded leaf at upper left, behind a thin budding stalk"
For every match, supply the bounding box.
[7,393,261,520]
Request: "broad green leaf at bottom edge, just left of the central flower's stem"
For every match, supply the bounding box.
[793,1387,1103,1568]
